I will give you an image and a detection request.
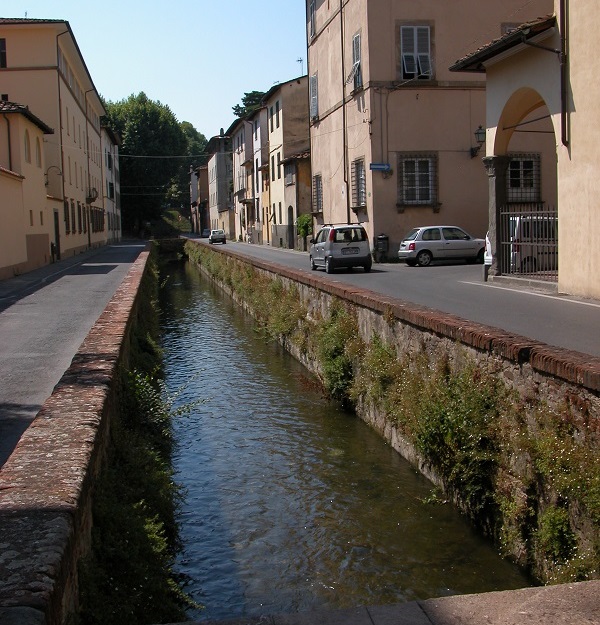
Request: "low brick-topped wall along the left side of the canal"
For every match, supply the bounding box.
[0,252,148,625]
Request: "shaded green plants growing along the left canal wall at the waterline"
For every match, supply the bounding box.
[79,246,196,625]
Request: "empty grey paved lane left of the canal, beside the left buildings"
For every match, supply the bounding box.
[0,241,146,466]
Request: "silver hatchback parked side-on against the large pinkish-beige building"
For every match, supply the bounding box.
[398,226,485,267]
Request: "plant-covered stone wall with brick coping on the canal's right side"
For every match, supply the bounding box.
[186,241,600,583]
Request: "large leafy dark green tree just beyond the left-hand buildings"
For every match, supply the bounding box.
[104,92,189,234]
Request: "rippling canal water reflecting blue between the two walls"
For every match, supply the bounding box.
[162,264,531,620]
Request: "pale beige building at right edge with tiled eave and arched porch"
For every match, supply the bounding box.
[454,0,600,298]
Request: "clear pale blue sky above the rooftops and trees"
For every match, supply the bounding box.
[0,0,307,139]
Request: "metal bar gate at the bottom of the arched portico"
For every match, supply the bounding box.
[498,203,558,282]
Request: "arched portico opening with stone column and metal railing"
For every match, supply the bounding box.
[484,87,558,281]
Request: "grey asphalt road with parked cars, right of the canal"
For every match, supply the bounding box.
[200,239,600,356]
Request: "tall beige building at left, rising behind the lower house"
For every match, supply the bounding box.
[0,18,121,276]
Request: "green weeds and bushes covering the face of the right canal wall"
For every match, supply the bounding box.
[186,244,600,583]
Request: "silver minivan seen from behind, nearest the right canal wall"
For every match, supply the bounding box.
[310,224,373,273]
